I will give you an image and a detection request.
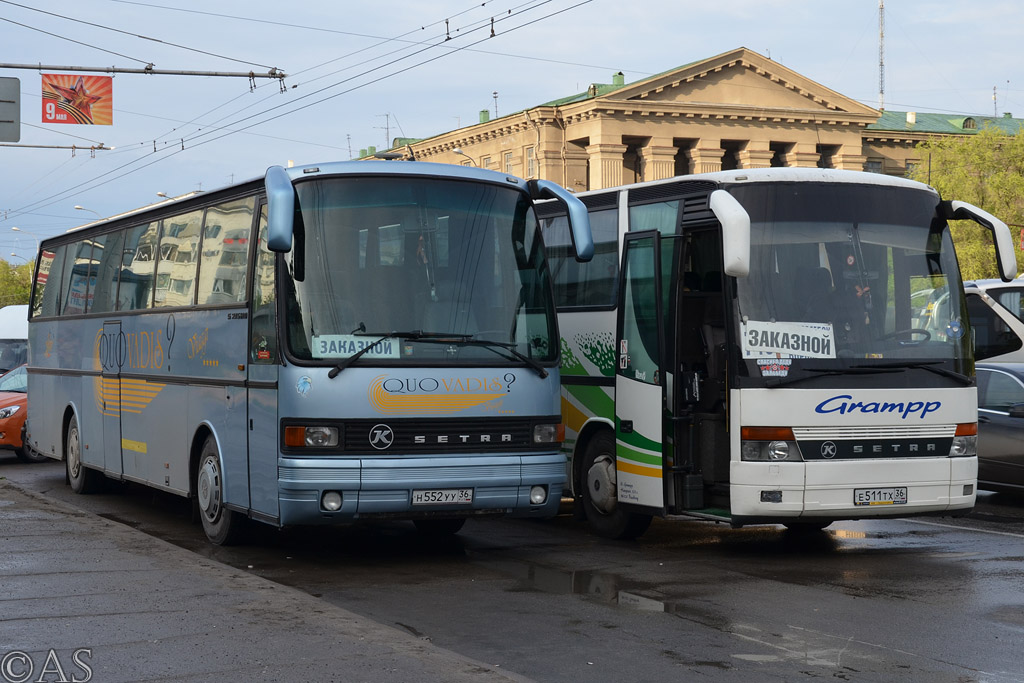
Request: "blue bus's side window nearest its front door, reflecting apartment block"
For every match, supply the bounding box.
[199,197,255,304]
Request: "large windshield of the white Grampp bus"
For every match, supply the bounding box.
[733,183,973,377]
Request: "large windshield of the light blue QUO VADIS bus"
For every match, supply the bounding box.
[285,176,558,366]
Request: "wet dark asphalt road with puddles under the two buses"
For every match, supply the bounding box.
[0,452,1024,683]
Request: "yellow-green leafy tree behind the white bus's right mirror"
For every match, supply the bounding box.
[911,126,1024,280]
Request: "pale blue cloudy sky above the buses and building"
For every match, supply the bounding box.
[0,0,1024,263]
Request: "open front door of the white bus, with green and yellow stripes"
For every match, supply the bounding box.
[615,230,666,515]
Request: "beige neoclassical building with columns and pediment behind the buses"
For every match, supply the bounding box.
[376,47,1024,191]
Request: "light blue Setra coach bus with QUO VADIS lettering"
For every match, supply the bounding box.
[29,162,593,544]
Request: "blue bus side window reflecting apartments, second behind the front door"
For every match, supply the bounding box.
[155,211,203,307]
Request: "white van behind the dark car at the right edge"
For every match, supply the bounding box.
[964,280,1024,362]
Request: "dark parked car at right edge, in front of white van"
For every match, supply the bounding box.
[976,362,1024,494]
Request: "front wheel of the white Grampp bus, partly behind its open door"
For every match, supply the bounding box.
[583,431,651,539]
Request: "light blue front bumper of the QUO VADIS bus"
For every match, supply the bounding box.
[278,453,566,525]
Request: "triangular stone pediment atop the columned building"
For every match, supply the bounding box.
[592,48,880,119]
